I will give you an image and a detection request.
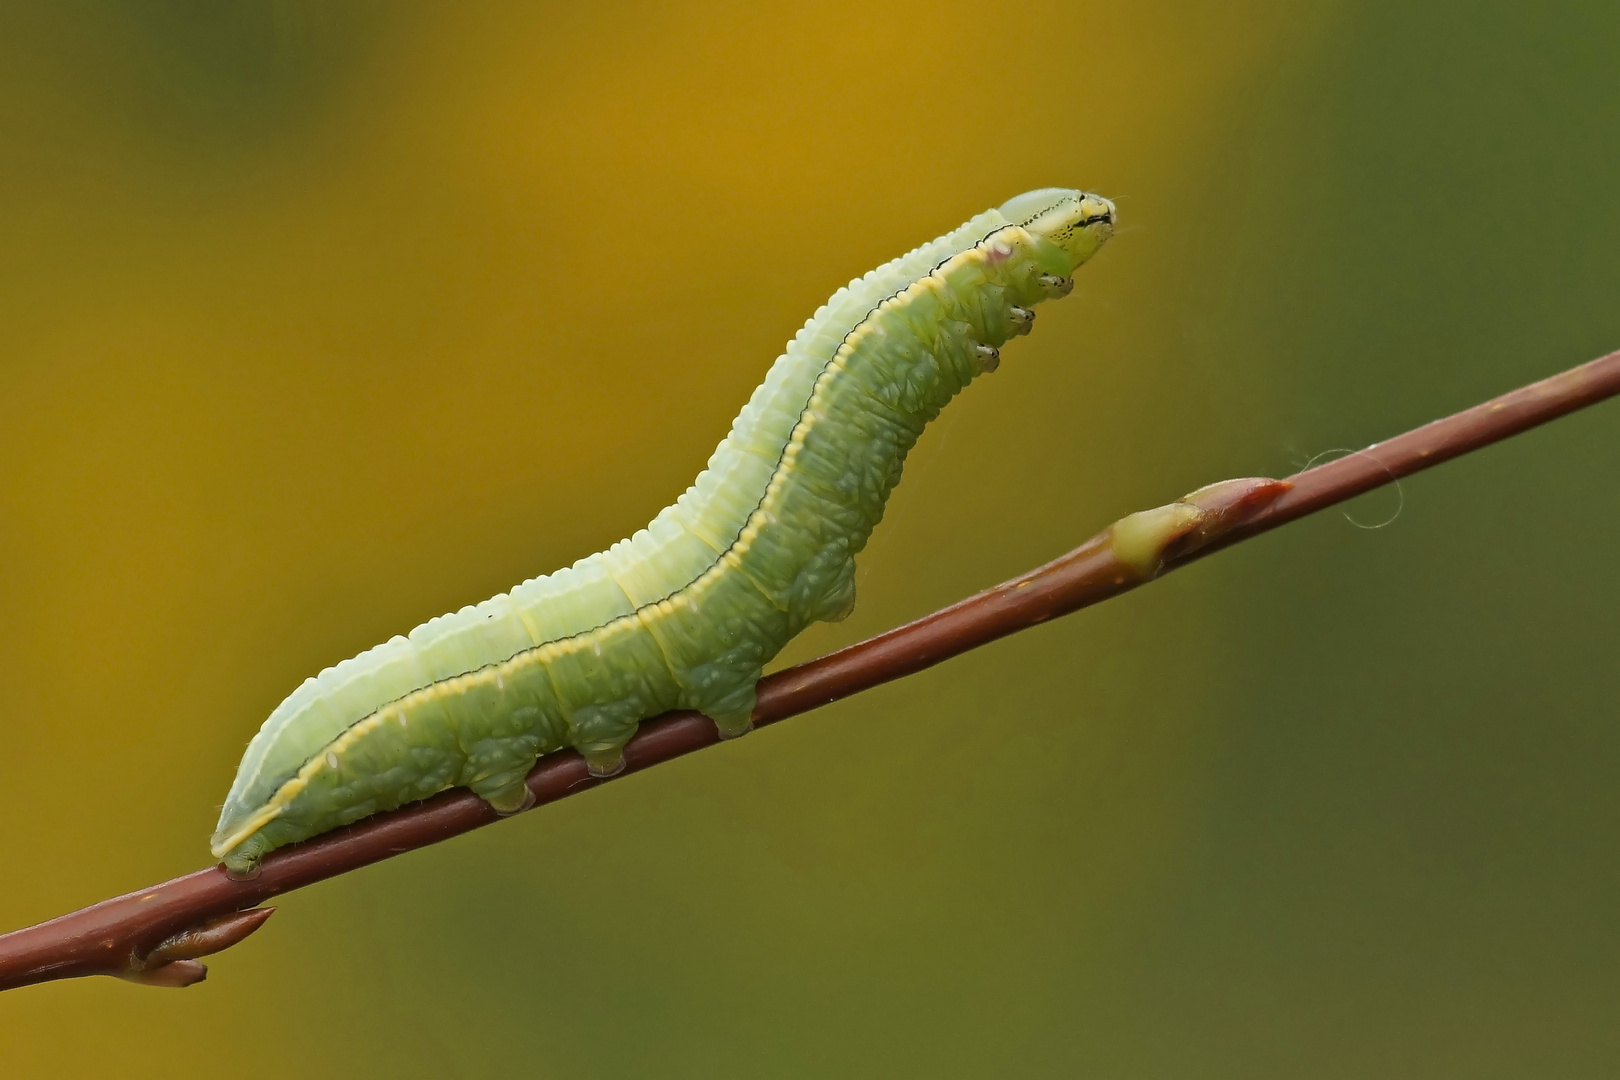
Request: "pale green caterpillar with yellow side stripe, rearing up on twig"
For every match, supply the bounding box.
[211,188,1116,874]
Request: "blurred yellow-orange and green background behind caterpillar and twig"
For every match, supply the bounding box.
[0,0,1620,1077]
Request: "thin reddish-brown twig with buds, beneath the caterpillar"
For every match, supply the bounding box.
[0,353,1620,989]
